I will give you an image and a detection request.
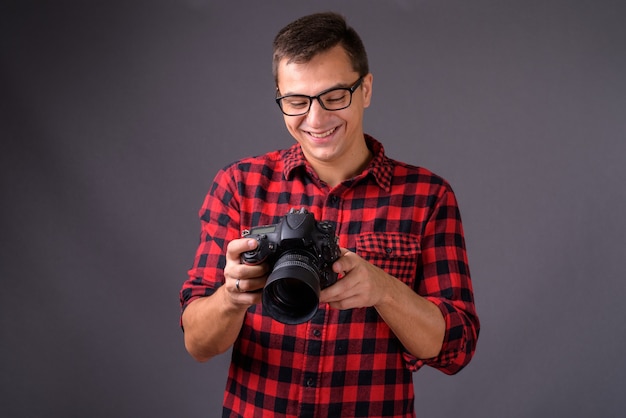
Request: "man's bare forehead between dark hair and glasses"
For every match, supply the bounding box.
[277,46,358,95]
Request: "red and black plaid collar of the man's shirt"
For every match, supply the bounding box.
[283,134,393,191]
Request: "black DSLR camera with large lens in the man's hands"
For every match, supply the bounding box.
[241,208,341,324]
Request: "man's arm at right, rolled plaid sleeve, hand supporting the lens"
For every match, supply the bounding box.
[320,188,480,374]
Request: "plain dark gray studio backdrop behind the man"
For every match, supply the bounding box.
[0,0,626,417]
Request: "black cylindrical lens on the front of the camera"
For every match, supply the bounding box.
[263,250,320,324]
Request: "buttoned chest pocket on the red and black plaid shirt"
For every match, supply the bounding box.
[356,232,420,287]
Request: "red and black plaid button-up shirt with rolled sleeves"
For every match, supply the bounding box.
[180,136,479,418]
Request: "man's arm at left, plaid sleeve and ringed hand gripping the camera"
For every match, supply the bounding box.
[180,166,266,361]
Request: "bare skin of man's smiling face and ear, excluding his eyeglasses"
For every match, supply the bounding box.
[278,46,372,175]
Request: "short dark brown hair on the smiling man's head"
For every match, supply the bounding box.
[272,12,369,85]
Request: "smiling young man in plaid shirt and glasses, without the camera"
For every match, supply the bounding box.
[181,13,479,417]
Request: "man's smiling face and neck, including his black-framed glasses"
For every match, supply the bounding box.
[276,45,373,187]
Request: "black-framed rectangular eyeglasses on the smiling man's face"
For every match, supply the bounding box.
[276,77,363,116]
